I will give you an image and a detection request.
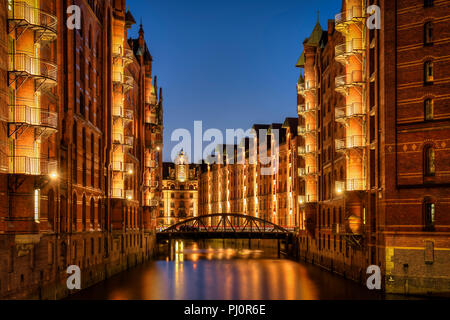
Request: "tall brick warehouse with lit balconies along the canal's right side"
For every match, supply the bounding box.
[297,0,450,294]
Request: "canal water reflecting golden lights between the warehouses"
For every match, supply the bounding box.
[69,240,408,300]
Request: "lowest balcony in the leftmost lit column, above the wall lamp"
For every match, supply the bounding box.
[8,156,58,176]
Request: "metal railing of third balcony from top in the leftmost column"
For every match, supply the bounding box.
[8,105,58,129]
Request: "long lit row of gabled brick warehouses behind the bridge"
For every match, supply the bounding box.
[199,118,301,229]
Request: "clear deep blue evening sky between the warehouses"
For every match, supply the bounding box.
[127,0,341,161]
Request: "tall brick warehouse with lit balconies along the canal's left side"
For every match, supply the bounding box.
[0,0,162,298]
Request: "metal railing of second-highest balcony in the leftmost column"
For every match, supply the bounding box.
[8,53,58,83]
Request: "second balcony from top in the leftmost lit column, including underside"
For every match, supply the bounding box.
[8,53,58,90]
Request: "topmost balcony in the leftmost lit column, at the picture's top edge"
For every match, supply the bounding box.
[7,1,58,42]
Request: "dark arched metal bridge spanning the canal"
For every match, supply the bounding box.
[157,213,291,241]
